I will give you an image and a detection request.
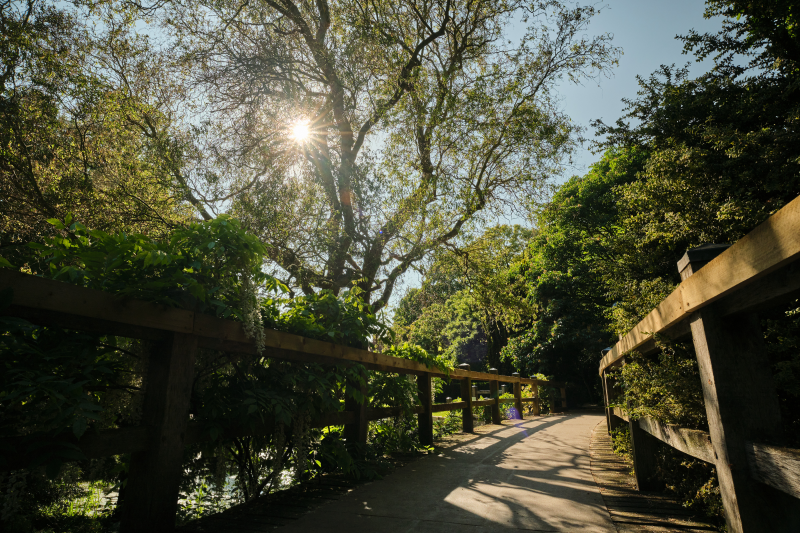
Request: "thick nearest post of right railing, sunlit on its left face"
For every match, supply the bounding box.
[678,250,800,533]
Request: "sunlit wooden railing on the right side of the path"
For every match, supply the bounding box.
[600,198,800,532]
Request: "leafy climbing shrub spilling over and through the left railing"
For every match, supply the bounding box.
[0,216,448,530]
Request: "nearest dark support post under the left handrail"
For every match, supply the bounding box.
[120,333,197,533]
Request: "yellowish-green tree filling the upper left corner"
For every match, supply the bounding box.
[0,0,191,258]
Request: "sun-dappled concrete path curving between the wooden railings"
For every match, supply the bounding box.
[280,413,616,533]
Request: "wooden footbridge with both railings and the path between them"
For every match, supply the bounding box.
[0,194,800,533]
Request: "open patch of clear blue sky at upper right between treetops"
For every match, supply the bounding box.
[560,0,722,177]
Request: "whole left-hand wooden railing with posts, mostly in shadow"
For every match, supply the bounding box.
[0,269,566,533]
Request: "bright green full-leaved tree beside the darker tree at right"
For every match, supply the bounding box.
[502,150,647,400]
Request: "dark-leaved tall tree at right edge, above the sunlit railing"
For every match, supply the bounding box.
[598,0,800,333]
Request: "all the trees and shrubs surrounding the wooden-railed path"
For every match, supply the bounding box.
[0,0,800,531]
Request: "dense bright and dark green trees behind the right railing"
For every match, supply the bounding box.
[395,0,800,523]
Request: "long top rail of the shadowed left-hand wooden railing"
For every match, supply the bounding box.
[0,269,563,387]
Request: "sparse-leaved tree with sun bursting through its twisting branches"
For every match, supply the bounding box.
[152,0,617,308]
